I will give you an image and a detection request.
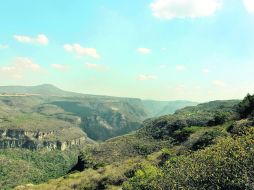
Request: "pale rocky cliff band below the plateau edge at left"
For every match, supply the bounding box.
[0,129,86,150]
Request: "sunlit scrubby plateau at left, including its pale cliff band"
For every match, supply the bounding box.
[0,96,89,150]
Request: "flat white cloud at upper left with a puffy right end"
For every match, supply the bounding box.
[13,34,49,45]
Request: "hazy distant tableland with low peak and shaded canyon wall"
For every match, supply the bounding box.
[0,84,197,141]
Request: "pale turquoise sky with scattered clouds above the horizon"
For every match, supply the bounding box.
[0,0,254,102]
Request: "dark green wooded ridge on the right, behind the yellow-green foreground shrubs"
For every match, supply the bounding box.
[140,100,239,140]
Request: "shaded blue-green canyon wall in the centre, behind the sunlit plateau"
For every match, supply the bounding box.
[52,98,146,140]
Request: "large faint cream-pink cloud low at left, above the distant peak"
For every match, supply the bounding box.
[0,57,42,79]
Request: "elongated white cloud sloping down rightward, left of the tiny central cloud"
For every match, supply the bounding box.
[64,44,100,59]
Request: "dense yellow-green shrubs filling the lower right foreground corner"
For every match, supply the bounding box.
[123,131,254,190]
